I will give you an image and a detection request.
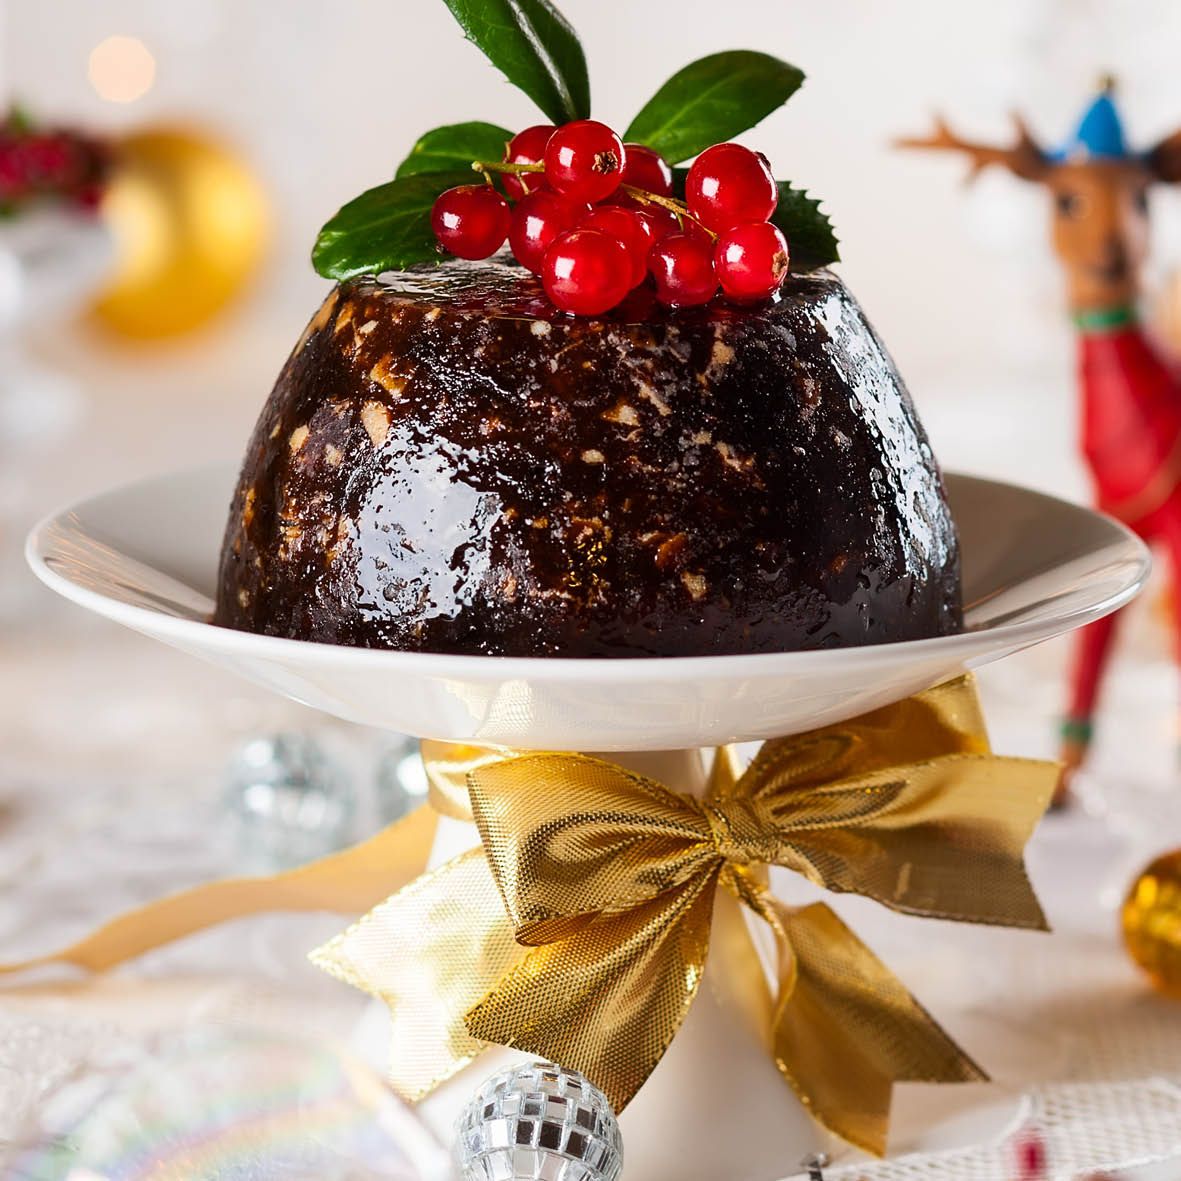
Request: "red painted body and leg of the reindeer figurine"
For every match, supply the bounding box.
[1069,324,1181,723]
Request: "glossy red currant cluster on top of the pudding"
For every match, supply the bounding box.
[431,119,788,315]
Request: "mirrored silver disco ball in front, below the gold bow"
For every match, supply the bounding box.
[456,1062,624,1181]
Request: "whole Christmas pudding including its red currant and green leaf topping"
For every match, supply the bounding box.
[216,20,961,657]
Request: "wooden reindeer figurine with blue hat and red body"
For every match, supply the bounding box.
[900,81,1181,803]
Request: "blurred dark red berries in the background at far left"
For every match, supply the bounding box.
[0,112,109,213]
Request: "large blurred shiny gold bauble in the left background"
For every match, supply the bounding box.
[93,126,270,340]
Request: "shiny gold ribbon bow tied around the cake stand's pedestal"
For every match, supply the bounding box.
[314,678,1057,1153]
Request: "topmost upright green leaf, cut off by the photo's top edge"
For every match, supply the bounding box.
[444,0,591,123]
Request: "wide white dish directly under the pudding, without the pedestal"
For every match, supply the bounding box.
[27,464,1149,751]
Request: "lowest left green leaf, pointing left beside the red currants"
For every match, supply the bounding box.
[312,169,474,281]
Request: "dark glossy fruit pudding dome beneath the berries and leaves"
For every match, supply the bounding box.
[216,261,961,657]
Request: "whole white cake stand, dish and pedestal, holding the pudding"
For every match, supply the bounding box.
[27,464,1149,1181]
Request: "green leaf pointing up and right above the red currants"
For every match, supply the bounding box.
[624,50,804,164]
